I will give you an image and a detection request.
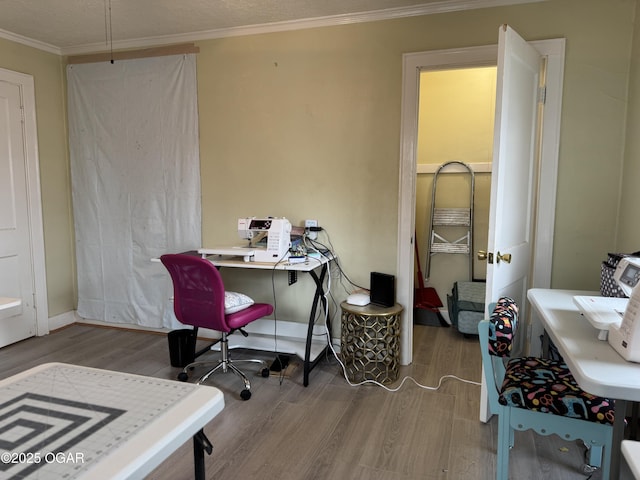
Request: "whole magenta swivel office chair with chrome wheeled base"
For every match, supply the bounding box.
[160,254,273,400]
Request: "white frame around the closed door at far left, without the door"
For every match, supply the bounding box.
[0,68,49,336]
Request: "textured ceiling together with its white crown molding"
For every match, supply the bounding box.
[0,0,544,55]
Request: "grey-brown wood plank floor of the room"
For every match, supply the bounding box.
[0,325,600,480]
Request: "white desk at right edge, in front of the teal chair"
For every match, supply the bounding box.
[527,288,640,479]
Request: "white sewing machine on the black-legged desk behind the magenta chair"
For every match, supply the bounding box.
[238,218,291,263]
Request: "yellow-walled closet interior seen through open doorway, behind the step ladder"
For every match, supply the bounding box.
[415,66,496,319]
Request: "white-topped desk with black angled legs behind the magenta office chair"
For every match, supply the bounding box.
[198,248,333,387]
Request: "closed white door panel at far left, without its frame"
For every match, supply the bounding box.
[0,81,36,347]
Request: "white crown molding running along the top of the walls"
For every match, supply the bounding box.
[0,0,548,55]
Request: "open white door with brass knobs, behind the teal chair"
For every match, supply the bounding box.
[478,25,543,421]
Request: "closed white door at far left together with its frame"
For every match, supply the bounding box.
[0,69,49,346]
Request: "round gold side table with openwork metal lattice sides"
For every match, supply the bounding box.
[340,302,403,384]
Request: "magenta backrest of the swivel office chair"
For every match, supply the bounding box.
[160,254,231,333]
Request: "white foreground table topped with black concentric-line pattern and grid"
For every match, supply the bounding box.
[0,363,224,480]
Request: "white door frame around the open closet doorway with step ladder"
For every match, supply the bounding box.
[396,38,565,365]
